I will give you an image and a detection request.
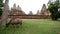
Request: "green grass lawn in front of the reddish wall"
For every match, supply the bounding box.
[0,19,60,34]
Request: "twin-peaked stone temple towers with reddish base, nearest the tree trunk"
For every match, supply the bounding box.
[10,4,25,15]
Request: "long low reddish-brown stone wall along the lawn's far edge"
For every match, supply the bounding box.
[9,15,51,19]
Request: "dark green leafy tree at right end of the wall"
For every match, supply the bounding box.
[48,0,60,20]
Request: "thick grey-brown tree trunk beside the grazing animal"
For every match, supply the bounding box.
[1,0,9,26]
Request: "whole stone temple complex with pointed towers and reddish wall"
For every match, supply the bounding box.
[9,4,51,18]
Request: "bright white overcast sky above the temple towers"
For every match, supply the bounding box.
[9,0,49,14]
